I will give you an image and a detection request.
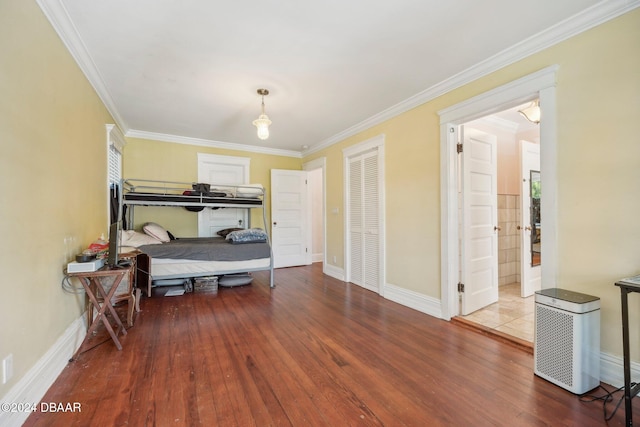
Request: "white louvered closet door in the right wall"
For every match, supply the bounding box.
[349,150,380,292]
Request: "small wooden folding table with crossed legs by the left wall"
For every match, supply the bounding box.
[67,266,132,361]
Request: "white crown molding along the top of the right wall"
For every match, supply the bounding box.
[303,0,640,156]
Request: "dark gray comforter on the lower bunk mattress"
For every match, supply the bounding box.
[138,237,271,261]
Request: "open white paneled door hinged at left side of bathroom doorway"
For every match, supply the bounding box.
[460,128,499,316]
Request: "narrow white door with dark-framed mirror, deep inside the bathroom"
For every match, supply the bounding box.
[520,141,542,298]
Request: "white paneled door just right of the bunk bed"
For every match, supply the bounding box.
[271,169,311,268]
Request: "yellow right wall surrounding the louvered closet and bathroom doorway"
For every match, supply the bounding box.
[303,10,640,360]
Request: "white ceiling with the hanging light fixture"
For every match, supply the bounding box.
[37,0,628,155]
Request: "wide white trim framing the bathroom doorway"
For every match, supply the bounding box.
[438,65,559,320]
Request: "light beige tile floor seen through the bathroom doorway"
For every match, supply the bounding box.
[463,283,535,343]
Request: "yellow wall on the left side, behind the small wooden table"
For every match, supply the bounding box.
[0,0,113,396]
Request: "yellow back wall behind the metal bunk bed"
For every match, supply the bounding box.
[123,138,302,237]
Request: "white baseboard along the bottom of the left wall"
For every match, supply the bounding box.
[0,313,87,427]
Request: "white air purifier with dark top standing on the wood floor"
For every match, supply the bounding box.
[533,288,600,394]
